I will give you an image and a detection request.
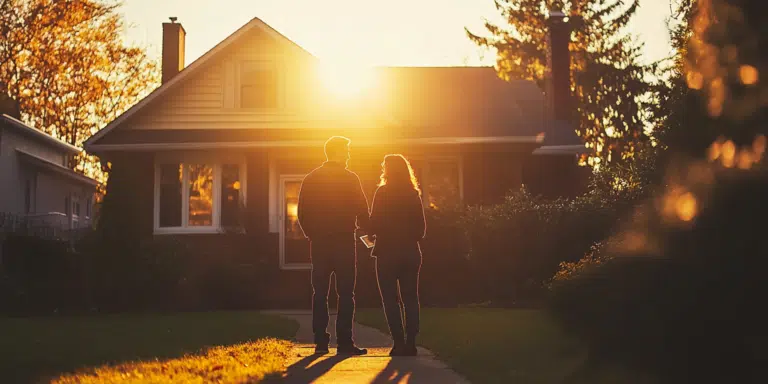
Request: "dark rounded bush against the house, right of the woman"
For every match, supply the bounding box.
[461,189,620,305]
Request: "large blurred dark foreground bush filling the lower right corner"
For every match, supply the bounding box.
[551,165,768,382]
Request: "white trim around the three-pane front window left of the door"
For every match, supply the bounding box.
[153,156,248,235]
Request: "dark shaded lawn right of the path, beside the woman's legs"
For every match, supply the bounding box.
[355,308,648,383]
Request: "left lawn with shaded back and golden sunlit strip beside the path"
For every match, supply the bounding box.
[0,312,298,383]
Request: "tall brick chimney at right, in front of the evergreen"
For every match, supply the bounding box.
[546,10,574,122]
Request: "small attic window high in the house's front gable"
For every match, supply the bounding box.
[240,62,279,109]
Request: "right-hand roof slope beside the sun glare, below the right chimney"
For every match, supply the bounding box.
[371,67,544,137]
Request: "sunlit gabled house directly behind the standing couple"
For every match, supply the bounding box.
[85,17,586,306]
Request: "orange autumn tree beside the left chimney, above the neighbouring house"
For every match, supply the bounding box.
[0,0,159,181]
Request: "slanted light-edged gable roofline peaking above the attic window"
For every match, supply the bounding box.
[84,17,316,149]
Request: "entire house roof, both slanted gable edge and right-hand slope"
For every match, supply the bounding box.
[85,18,545,150]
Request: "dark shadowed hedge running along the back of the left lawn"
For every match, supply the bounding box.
[0,232,274,315]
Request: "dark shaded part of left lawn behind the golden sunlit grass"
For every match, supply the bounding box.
[0,312,298,383]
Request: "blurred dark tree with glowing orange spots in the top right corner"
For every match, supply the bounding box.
[655,0,768,160]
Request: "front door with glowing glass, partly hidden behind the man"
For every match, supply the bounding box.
[279,175,311,269]
